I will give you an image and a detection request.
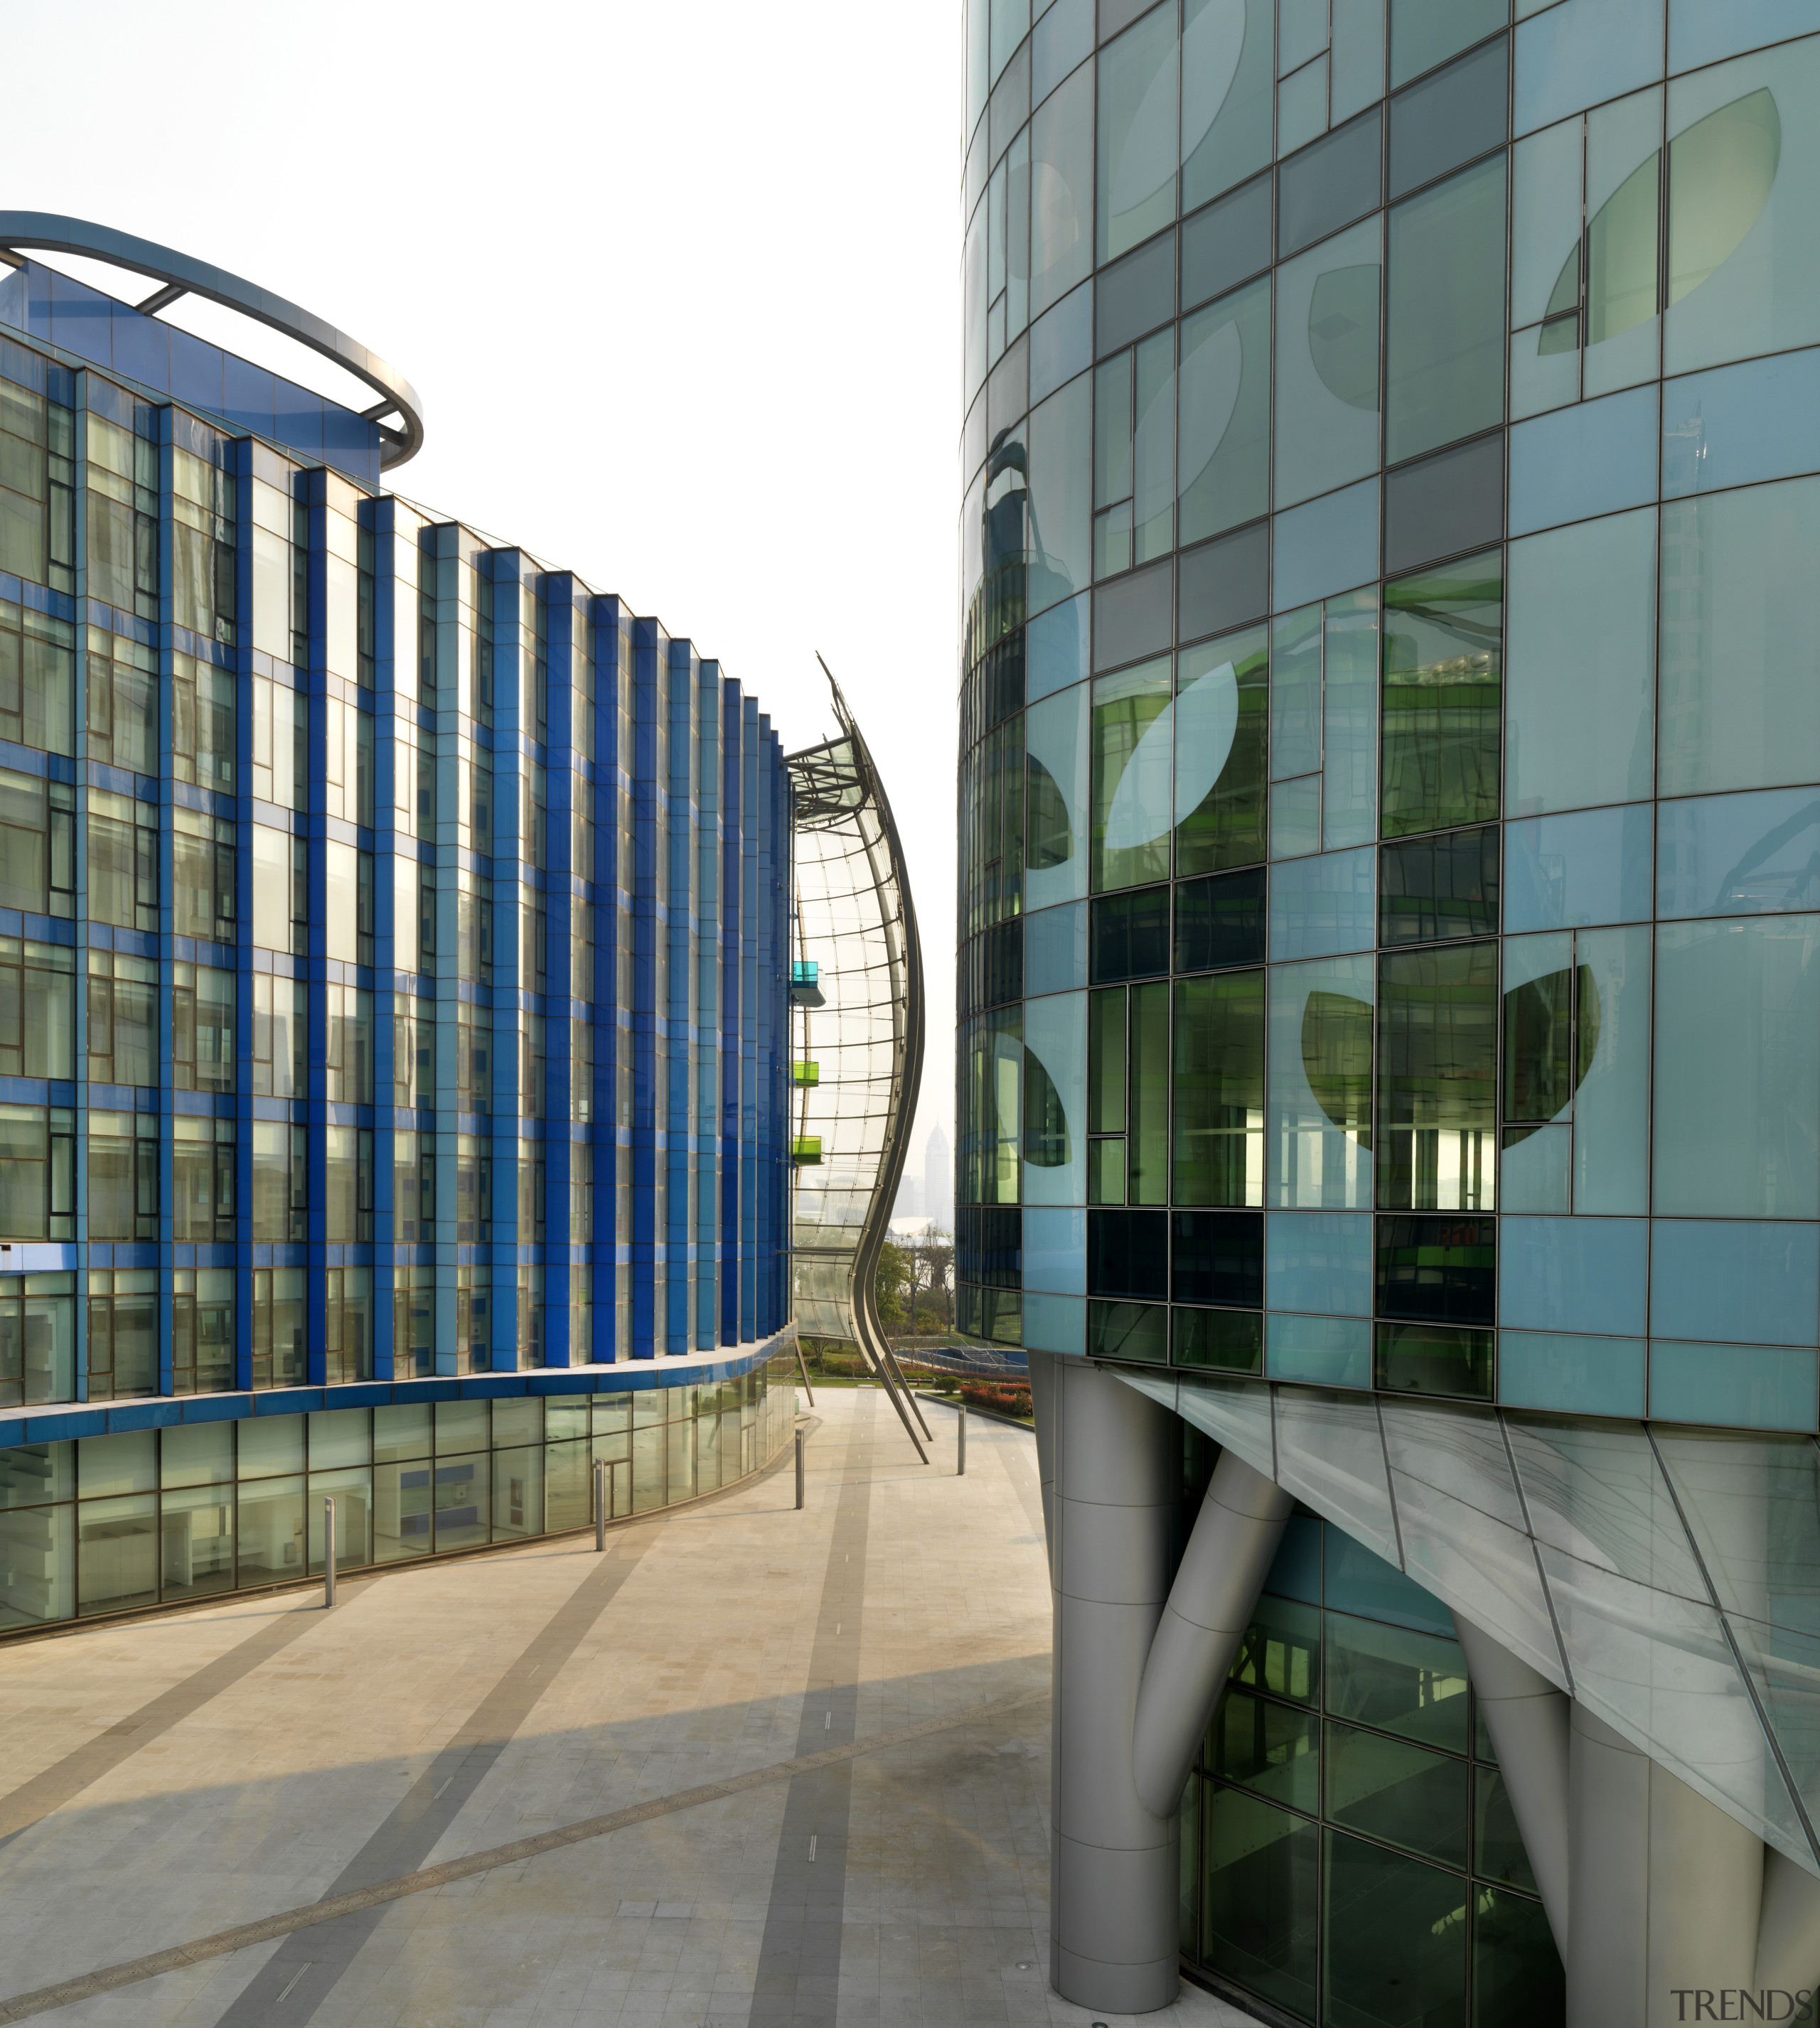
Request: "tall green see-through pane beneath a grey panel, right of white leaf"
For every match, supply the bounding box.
[1383,549,1504,837]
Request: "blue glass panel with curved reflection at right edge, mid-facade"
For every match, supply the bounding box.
[1656,789,1820,917]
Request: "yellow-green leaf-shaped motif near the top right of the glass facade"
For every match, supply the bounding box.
[1536,87,1782,353]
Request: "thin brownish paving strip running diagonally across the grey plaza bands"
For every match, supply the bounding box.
[0,1685,1049,2022]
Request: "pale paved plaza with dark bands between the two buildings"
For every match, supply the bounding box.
[0,1389,1242,2028]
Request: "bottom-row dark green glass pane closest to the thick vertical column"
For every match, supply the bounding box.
[1201,1783,1321,2020]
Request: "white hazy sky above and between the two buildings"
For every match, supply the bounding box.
[6,0,962,1166]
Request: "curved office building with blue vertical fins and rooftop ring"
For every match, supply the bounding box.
[0,226,793,1626]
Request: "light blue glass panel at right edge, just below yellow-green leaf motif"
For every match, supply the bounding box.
[1661,349,1820,499]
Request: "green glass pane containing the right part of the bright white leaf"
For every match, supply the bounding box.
[1168,627,1270,876]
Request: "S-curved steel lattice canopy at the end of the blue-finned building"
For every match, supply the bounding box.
[787,657,929,1462]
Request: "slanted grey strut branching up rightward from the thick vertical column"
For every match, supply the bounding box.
[1133,1450,1295,1817]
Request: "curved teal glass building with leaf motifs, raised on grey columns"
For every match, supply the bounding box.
[956,0,1820,2028]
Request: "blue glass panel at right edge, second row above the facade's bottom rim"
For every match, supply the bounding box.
[1649,1219,1820,1345]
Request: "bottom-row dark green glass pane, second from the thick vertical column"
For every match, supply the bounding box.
[1321,1831,1469,2028]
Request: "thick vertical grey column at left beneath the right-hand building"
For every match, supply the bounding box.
[1049,1359,1181,2014]
